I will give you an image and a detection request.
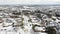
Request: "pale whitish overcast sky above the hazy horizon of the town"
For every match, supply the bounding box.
[0,0,60,5]
